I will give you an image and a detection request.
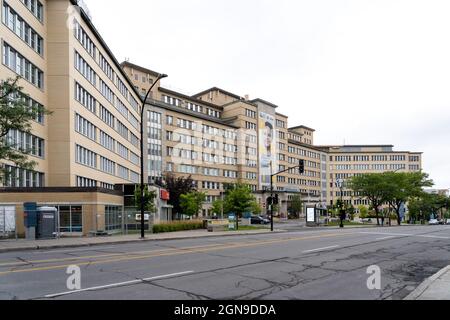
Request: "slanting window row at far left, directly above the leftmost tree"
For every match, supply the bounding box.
[3,42,44,89]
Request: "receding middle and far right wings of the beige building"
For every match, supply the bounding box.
[122,62,422,216]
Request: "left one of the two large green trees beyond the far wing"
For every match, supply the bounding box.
[348,173,386,225]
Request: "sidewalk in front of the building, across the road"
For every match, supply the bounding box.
[0,230,284,253]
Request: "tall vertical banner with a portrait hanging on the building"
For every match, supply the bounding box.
[258,112,277,189]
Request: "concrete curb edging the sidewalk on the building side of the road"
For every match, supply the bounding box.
[0,230,288,253]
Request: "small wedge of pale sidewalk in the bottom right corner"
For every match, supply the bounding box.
[404,266,450,300]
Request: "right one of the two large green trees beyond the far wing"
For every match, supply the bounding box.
[382,172,433,225]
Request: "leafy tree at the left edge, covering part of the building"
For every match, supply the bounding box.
[0,77,50,181]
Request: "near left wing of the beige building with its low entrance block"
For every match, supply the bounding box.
[0,0,141,234]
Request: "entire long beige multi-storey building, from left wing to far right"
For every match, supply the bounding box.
[0,0,422,235]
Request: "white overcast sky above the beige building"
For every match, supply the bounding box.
[85,0,450,188]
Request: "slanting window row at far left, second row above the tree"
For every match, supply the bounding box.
[2,2,44,55]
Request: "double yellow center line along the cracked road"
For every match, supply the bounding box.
[0,233,355,276]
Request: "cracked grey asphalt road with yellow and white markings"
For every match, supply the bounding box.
[0,226,450,300]
